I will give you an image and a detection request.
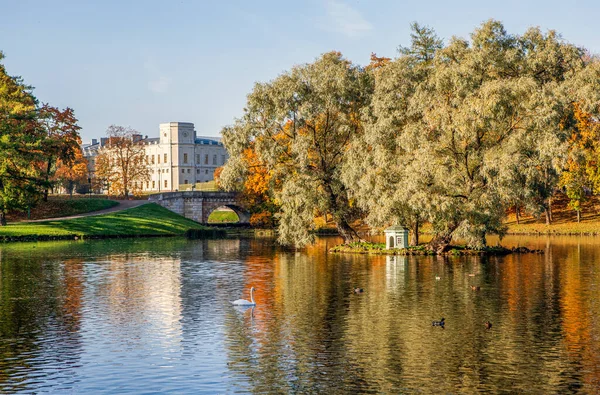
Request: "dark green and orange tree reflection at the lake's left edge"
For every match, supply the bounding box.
[0,251,82,392]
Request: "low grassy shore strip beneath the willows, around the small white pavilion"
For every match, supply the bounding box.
[329,242,541,256]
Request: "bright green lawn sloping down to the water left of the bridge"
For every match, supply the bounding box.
[0,203,223,241]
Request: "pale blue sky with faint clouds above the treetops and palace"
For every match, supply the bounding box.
[0,0,600,141]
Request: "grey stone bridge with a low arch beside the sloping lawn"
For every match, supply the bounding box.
[148,191,250,224]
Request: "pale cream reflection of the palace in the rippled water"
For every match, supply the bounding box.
[100,255,182,346]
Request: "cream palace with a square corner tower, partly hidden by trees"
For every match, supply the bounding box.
[82,122,228,192]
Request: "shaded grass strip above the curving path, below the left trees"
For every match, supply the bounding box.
[8,197,119,222]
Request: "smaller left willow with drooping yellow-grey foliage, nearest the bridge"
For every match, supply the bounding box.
[220,52,372,246]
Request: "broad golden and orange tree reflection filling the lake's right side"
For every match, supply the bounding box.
[225,238,600,393]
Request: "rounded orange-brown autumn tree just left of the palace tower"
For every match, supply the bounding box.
[96,125,150,197]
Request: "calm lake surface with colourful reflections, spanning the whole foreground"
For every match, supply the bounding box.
[0,237,600,394]
